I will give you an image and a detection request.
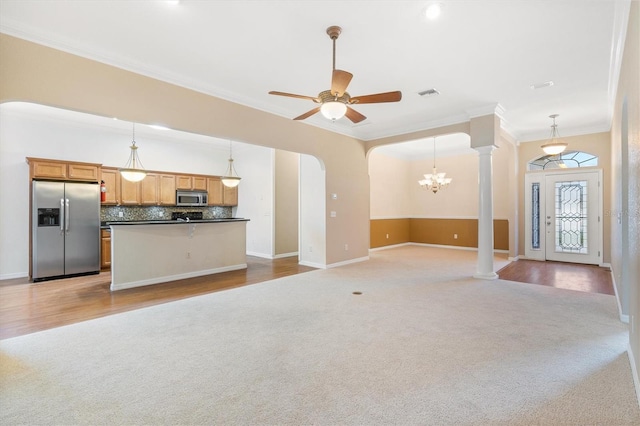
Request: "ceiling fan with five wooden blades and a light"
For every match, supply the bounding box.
[269,26,402,123]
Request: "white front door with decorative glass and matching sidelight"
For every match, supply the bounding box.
[525,170,602,264]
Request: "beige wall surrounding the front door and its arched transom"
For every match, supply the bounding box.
[518,128,611,263]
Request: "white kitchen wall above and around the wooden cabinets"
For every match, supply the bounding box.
[0,103,273,279]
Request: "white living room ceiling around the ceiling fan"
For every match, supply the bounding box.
[0,0,629,150]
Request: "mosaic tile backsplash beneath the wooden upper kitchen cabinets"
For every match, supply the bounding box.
[100,206,233,222]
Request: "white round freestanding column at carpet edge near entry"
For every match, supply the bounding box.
[473,145,498,280]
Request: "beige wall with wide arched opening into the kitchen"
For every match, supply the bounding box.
[0,34,369,264]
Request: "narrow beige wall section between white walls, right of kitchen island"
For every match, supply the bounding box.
[274,149,300,257]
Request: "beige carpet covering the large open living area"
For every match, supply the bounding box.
[0,246,640,425]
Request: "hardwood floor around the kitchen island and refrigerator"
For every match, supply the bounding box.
[0,256,315,339]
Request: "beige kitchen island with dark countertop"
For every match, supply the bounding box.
[107,219,248,291]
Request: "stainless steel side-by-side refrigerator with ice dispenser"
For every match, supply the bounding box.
[31,181,100,282]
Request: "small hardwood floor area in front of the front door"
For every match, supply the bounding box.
[498,260,615,295]
